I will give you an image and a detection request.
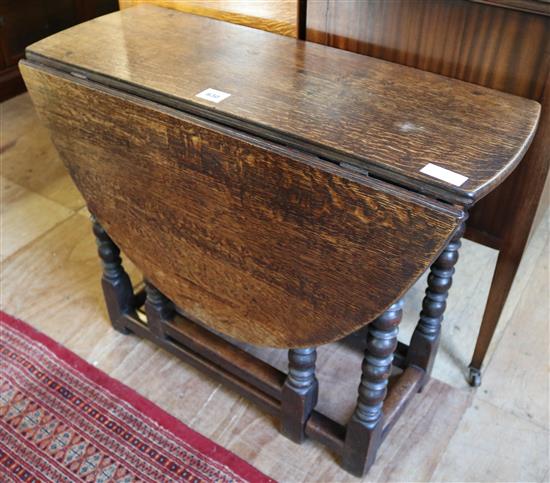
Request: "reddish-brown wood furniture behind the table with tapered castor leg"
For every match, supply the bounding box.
[307,0,550,382]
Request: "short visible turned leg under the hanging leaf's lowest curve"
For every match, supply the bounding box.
[281,348,319,443]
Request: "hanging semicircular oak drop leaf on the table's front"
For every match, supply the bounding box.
[21,63,462,347]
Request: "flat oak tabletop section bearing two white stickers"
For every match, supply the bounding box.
[23,6,539,203]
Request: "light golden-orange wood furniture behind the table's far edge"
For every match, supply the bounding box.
[119,0,298,37]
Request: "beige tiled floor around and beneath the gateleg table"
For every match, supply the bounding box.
[0,95,550,481]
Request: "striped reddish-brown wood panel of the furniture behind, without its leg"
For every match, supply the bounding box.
[307,0,550,242]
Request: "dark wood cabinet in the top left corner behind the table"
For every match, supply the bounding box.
[0,0,118,101]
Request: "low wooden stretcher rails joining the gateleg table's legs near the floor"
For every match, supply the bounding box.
[120,308,424,464]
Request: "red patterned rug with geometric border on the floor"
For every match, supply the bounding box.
[0,311,272,483]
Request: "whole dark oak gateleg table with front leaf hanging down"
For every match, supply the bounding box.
[20,6,540,476]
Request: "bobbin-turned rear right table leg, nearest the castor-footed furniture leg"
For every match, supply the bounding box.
[407,223,465,389]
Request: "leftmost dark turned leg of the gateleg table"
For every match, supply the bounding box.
[92,216,135,334]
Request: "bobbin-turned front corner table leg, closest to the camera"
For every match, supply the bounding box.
[342,301,403,477]
